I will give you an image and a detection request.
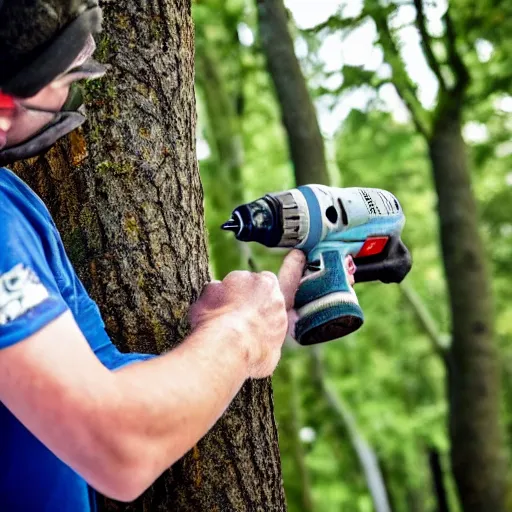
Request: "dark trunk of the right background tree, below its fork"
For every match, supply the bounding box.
[429,106,506,512]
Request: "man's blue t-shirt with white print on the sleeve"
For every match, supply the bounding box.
[0,169,153,512]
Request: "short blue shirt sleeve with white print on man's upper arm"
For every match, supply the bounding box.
[0,205,68,349]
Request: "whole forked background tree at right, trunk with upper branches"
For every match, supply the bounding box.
[306,0,506,510]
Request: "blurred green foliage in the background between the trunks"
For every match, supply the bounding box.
[194,0,512,512]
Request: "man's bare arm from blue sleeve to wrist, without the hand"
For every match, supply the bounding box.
[0,313,249,501]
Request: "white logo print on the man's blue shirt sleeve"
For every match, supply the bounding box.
[0,263,49,325]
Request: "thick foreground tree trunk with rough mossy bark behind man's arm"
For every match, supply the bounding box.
[17,0,285,512]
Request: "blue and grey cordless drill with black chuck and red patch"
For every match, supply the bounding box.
[222,185,412,345]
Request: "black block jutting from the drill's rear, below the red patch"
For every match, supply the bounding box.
[354,236,412,283]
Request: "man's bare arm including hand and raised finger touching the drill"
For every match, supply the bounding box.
[0,251,304,501]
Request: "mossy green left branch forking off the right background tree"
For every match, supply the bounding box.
[371,8,431,139]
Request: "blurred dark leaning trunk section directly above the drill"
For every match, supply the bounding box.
[257,0,329,185]
